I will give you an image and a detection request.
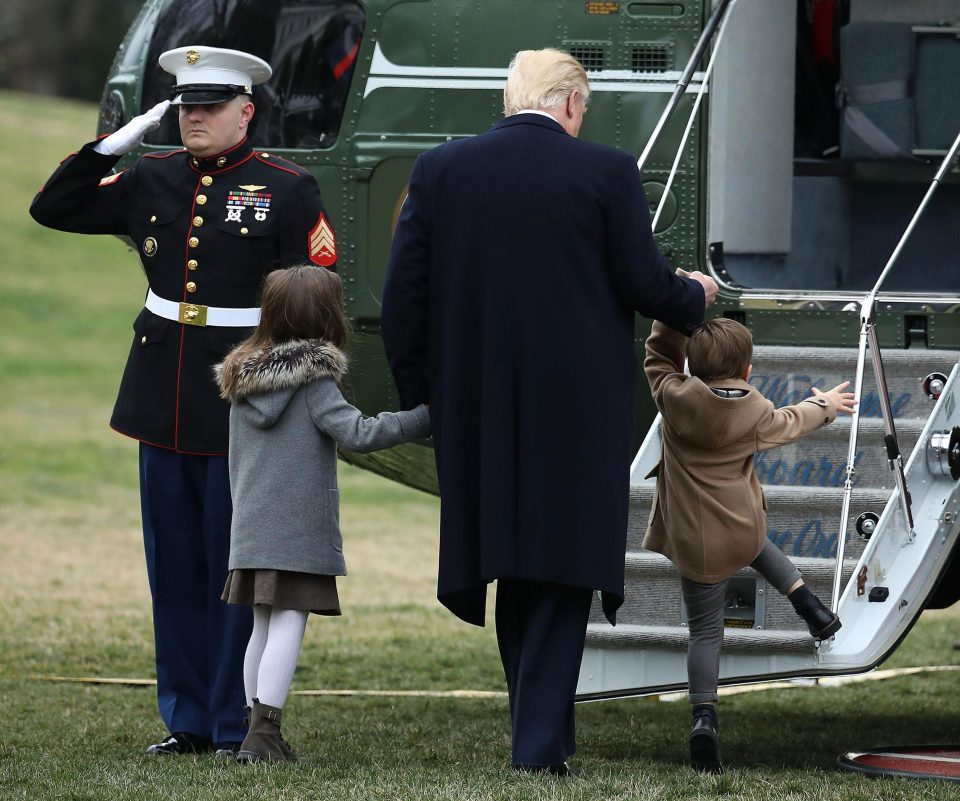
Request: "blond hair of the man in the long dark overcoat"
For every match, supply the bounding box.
[503,47,590,117]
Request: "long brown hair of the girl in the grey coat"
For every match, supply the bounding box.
[220,264,350,398]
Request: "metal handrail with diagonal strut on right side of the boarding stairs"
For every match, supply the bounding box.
[831,132,960,611]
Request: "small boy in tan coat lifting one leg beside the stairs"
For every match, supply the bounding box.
[643,319,854,773]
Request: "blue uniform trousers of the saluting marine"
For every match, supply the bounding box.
[140,444,251,742]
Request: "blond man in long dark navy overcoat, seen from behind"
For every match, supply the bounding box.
[382,50,716,775]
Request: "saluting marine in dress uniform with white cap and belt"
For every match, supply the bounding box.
[30,46,336,756]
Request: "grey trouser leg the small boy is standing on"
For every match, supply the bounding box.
[680,578,727,704]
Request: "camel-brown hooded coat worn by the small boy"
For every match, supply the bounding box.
[643,322,836,584]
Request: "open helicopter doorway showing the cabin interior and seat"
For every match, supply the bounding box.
[707,0,960,297]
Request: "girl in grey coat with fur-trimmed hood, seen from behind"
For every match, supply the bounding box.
[216,265,430,762]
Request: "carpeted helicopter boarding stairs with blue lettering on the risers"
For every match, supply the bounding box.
[578,346,960,699]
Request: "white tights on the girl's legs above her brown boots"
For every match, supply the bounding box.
[243,604,307,709]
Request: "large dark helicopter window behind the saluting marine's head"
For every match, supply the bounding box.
[140,0,364,148]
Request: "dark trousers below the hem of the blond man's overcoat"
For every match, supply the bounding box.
[496,579,591,765]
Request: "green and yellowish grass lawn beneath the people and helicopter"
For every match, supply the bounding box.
[0,93,960,801]
